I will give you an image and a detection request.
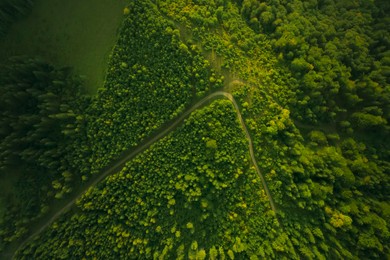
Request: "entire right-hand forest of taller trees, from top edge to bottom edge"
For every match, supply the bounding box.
[233,0,390,258]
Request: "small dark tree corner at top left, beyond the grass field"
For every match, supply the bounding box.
[0,0,34,39]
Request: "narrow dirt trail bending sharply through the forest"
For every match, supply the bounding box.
[9,91,276,259]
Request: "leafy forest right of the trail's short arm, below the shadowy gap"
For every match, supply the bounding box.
[244,85,389,258]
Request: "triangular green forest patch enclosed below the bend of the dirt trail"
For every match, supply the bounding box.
[18,100,286,259]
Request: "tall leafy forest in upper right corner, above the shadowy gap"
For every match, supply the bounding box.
[241,0,390,127]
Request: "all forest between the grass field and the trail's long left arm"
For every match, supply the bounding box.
[0,2,223,254]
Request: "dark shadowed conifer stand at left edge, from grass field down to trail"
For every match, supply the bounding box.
[0,57,88,252]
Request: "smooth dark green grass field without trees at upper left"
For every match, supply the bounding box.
[0,0,126,94]
